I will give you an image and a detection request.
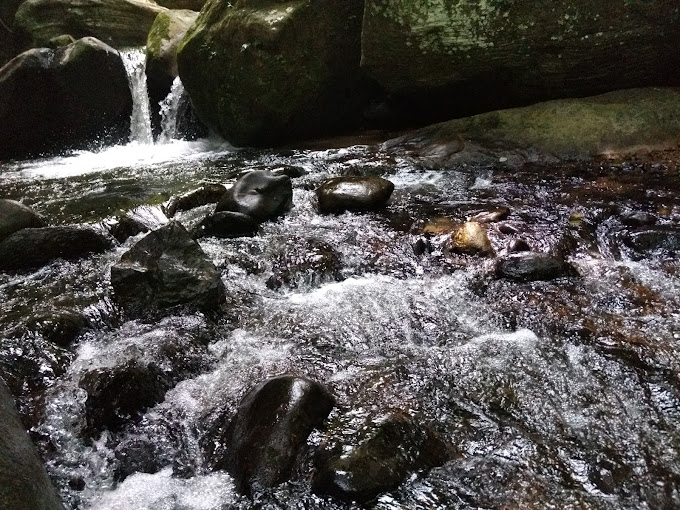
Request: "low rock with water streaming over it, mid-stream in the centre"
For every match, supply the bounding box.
[267,239,342,289]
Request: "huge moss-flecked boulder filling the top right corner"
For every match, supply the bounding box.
[361,0,680,120]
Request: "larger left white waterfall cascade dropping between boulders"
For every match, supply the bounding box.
[120,48,153,145]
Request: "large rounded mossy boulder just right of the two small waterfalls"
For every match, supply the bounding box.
[177,0,364,145]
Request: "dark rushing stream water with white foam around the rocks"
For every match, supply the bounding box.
[0,138,680,510]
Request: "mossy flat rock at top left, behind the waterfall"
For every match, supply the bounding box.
[15,0,166,48]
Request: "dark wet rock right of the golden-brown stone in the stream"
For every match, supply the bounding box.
[496,252,572,282]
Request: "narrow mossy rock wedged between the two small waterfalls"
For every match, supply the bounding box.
[146,10,198,103]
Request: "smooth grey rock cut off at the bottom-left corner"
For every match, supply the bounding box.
[0,378,64,510]
